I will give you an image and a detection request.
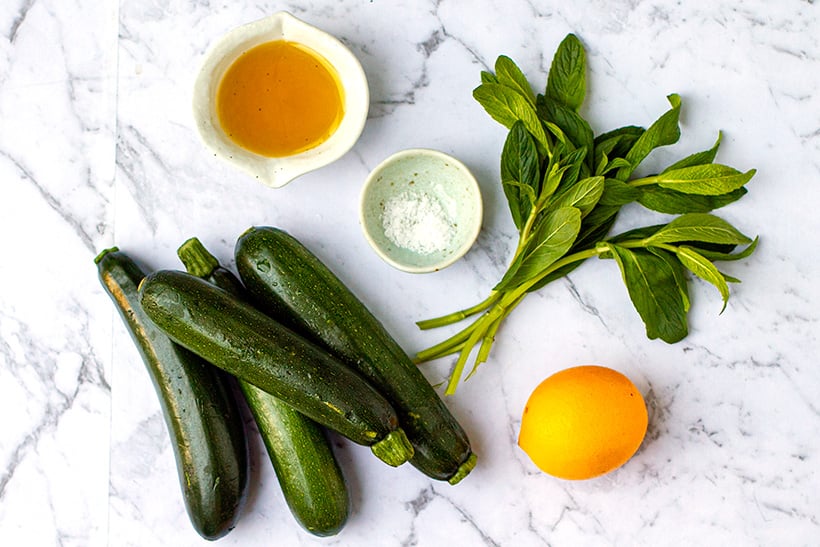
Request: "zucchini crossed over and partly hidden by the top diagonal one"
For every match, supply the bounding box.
[177,237,350,536]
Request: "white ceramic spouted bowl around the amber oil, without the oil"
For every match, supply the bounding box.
[193,11,370,188]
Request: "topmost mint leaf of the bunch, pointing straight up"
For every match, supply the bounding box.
[546,34,587,111]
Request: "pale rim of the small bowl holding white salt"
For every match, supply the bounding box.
[359,148,484,273]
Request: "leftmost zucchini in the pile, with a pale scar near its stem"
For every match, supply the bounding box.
[94,247,249,540]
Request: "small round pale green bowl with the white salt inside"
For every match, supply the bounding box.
[360,148,483,273]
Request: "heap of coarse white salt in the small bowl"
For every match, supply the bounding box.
[382,192,454,254]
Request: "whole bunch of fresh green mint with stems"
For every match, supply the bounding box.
[416,34,757,395]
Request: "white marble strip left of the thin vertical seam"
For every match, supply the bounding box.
[0,1,117,545]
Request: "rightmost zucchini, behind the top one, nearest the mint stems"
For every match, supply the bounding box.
[235,227,476,484]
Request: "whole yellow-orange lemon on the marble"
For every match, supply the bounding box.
[518,365,648,480]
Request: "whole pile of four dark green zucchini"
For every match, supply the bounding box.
[95,227,476,539]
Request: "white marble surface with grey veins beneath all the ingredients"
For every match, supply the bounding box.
[0,0,820,546]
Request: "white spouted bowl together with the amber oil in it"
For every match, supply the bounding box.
[193,11,370,188]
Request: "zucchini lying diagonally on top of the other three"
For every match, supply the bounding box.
[140,270,413,466]
